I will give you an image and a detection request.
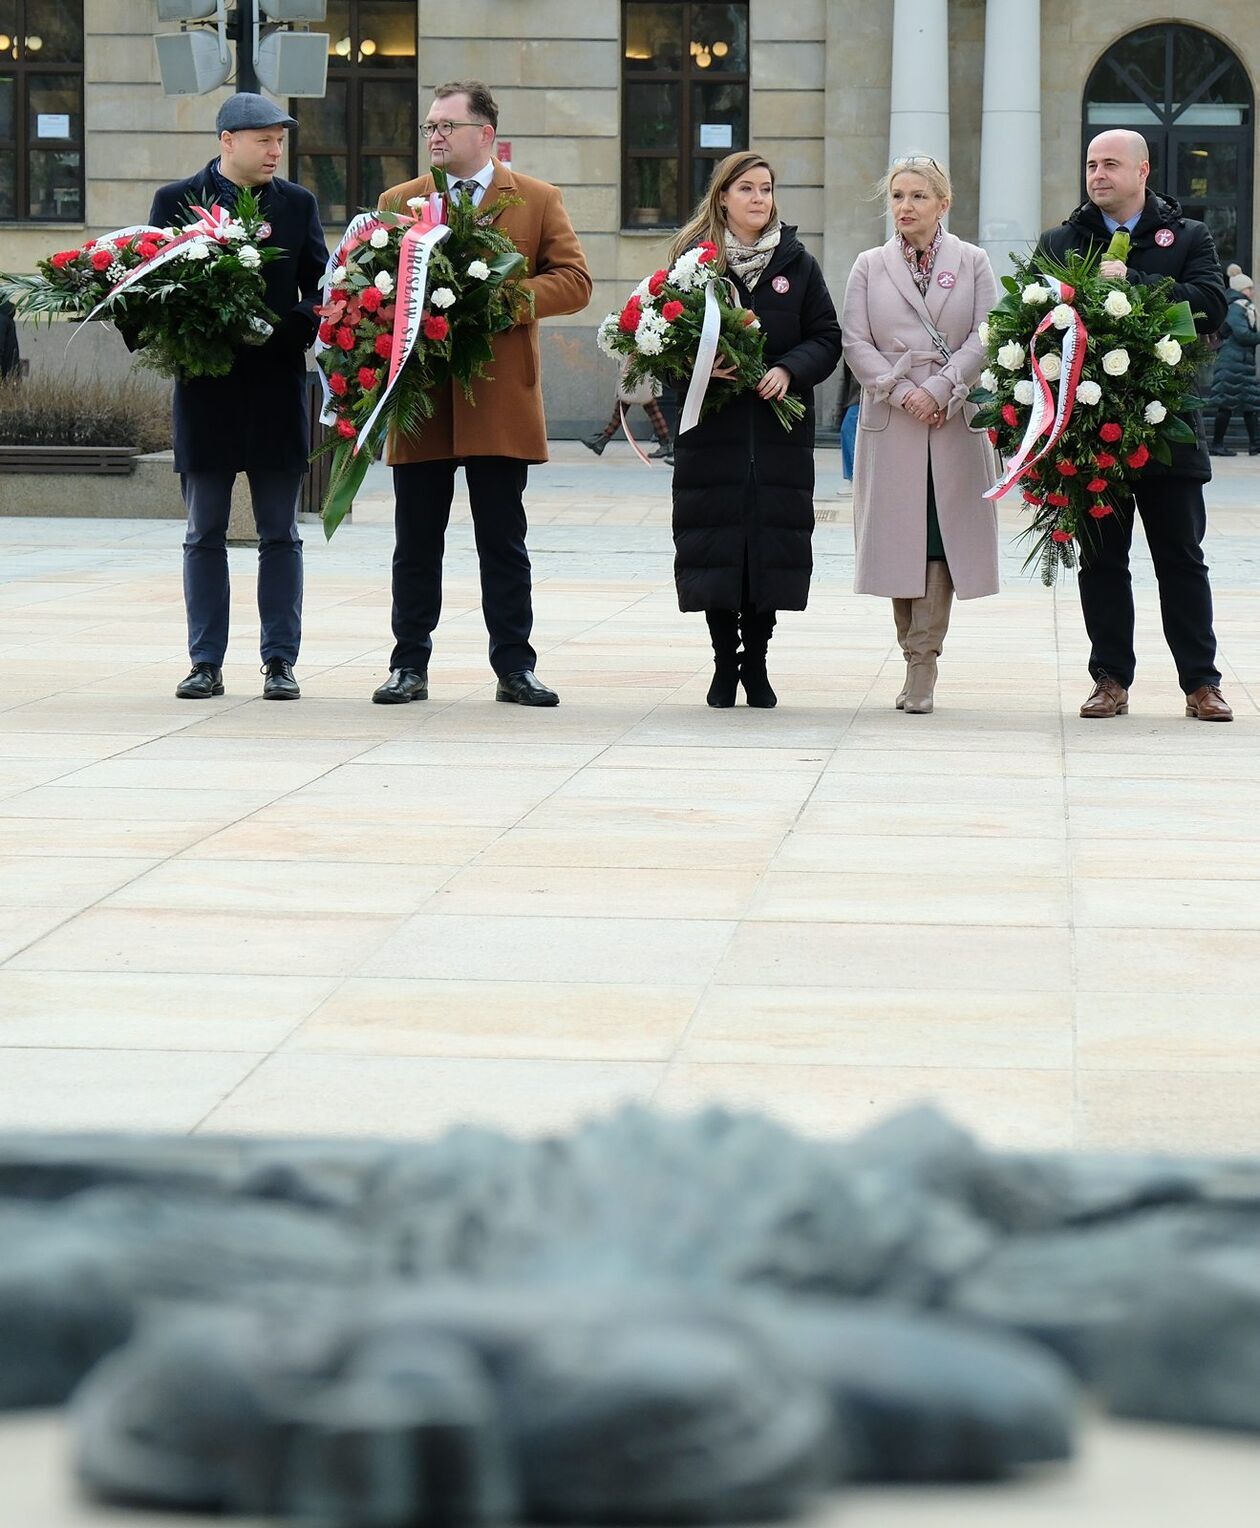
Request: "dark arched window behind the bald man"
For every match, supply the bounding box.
[1083,24,1255,269]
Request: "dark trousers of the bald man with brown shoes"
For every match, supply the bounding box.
[1078,477,1220,695]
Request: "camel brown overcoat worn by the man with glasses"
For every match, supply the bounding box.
[379,162,591,466]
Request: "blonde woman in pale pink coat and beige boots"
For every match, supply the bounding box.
[843,154,997,714]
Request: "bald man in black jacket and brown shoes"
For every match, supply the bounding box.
[1039,130,1234,721]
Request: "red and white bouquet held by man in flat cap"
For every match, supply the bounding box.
[0,189,281,379]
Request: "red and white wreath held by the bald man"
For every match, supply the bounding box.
[971,234,1202,584]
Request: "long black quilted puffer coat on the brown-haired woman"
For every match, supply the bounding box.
[674,226,840,610]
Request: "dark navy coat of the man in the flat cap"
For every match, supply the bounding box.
[148,165,328,472]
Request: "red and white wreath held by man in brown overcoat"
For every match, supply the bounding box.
[315,170,533,536]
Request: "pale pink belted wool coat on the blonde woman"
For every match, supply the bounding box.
[843,232,997,599]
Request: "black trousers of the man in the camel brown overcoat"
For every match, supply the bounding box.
[389,457,538,675]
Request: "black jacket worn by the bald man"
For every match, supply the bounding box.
[1039,191,1226,483]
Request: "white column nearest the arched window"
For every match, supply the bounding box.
[981,0,1042,277]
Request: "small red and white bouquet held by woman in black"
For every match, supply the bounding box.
[596,240,805,434]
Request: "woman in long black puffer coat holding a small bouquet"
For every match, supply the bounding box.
[670,151,840,706]
